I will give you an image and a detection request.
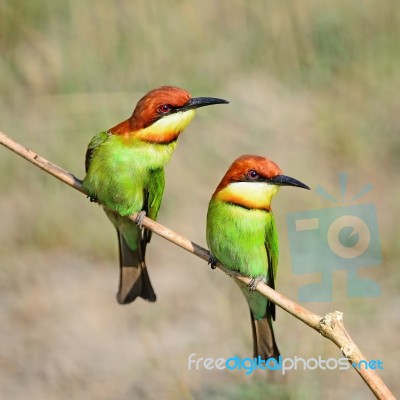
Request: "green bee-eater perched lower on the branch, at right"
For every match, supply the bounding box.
[207,155,309,360]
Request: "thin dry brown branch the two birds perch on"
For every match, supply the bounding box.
[0,132,395,400]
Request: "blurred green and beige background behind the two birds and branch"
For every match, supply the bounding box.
[0,0,400,400]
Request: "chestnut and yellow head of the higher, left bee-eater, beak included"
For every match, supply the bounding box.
[110,86,228,143]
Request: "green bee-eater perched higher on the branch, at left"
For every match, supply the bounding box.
[83,86,228,304]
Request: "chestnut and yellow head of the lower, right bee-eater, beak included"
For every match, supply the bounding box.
[213,155,310,211]
